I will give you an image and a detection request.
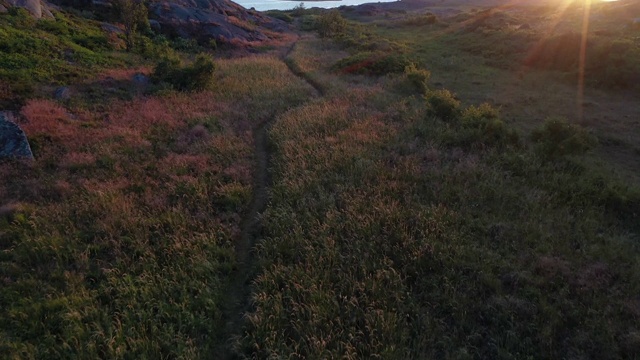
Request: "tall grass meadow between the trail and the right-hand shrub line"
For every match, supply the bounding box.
[244,14,640,359]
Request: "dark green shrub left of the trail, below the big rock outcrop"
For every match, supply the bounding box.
[152,54,216,91]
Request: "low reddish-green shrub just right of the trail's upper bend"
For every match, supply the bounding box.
[333,52,411,76]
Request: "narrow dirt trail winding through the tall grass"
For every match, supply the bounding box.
[213,36,326,360]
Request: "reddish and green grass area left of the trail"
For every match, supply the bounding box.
[0,7,311,359]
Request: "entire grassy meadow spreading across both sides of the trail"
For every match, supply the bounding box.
[0,3,640,359]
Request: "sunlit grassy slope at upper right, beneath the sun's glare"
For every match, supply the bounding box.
[373,3,640,184]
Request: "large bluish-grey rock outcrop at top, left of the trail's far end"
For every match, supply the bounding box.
[149,0,288,43]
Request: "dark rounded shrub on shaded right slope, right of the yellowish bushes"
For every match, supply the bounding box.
[531,118,597,158]
